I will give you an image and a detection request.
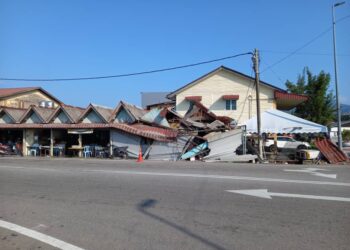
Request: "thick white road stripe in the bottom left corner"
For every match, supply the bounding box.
[0,220,84,250]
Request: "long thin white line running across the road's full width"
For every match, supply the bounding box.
[0,166,350,187]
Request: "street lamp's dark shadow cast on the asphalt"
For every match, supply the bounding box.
[137,199,225,250]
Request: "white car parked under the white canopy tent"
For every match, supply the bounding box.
[264,136,310,152]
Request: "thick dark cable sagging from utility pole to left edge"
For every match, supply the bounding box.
[0,52,252,82]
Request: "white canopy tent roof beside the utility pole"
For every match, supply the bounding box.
[242,109,328,134]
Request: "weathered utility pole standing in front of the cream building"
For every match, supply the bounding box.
[252,49,264,160]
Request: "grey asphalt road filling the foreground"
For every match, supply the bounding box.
[0,158,350,250]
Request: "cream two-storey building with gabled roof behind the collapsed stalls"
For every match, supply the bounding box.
[167,66,307,124]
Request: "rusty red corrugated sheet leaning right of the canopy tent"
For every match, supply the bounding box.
[315,139,348,164]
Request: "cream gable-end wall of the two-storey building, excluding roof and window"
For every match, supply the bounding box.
[176,70,276,124]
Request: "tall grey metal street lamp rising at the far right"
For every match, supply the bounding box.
[332,2,345,150]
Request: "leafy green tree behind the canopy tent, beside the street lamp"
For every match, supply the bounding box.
[286,67,335,125]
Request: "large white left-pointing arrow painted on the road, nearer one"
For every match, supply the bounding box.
[226,189,350,202]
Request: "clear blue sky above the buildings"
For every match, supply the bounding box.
[0,0,350,107]
